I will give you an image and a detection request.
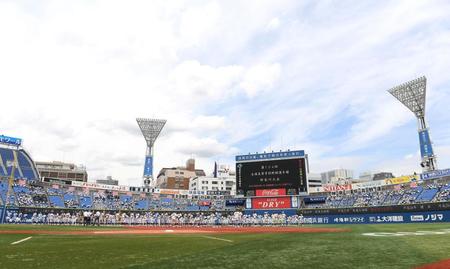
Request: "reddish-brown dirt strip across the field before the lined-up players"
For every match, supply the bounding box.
[0,226,350,235]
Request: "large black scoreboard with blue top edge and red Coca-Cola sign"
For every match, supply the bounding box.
[236,150,308,197]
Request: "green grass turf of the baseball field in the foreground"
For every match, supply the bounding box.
[0,224,450,269]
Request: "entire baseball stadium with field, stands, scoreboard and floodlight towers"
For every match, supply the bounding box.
[0,77,450,269]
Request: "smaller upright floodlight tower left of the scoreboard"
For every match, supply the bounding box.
[136,118,166,187]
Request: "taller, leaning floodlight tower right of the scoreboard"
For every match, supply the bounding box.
[389,77,437,172]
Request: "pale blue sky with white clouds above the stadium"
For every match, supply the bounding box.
[0,0,450,185]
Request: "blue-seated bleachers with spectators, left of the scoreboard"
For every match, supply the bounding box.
[0,179,243,211]
